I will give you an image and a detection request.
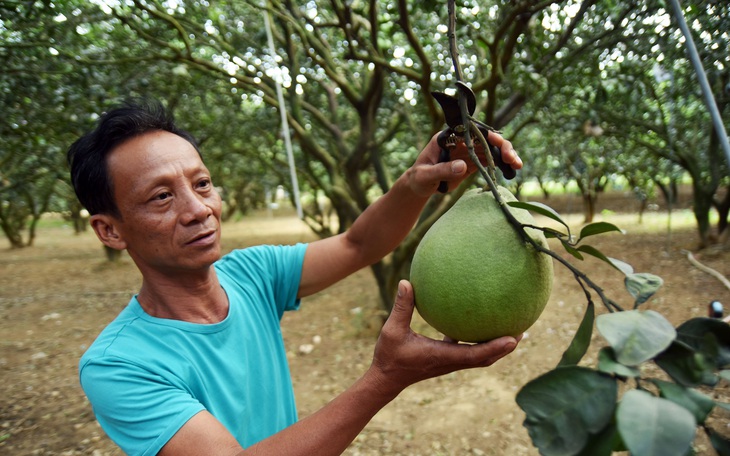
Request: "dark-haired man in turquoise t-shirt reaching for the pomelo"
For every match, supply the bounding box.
[68,100,522,455]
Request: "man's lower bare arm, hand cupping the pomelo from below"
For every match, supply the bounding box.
[160,281,518,456]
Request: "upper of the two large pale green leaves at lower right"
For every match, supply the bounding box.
[596,310,677,366]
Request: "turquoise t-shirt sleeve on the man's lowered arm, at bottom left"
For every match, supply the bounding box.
[80,358,205,455]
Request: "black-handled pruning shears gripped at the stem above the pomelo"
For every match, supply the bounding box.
[431,81,517,193]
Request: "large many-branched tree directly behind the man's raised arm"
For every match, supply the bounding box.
[67,1,660,303]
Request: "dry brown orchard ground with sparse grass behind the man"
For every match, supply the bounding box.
[0,187,730,455]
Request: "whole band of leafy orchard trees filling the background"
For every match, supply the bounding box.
[0,0,730,306]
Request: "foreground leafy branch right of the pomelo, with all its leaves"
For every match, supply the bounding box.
[517,203,730,456]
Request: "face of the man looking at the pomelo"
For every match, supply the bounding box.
[100,131,221,274]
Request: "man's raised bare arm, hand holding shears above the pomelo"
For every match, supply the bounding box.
[298,132,522,298]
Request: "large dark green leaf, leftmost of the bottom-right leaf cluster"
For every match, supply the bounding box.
[516,366,618,456]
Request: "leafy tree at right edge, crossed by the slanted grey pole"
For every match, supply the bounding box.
[601,2,730,246]
